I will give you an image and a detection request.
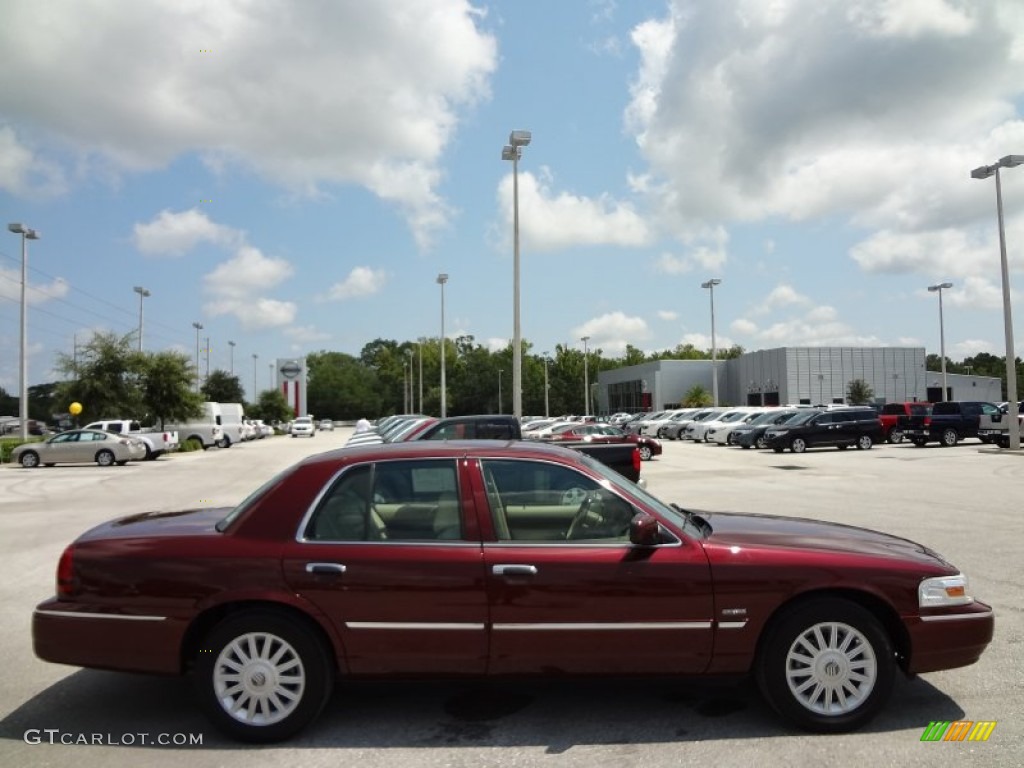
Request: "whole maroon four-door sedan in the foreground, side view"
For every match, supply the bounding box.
[33,440,994,741]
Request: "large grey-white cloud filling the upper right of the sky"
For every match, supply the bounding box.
[626,0,1024,249]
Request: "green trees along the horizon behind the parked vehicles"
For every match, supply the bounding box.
[0,333,1022,426]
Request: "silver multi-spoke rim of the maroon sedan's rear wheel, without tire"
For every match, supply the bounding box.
[213,632,306,725]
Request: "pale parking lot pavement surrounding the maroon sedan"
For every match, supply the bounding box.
[0,429,1024,768]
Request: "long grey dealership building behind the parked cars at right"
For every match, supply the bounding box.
[594,347,1002,414]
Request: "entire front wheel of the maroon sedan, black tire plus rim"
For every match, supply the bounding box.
[757,597,896,733]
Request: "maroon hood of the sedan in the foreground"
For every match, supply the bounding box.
[695,512,953,568]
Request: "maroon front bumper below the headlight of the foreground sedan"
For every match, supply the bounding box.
[906,602,995,674]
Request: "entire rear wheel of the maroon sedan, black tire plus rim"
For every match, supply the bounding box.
[194,611,335,743]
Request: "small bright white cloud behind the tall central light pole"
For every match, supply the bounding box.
[498,169,652,251]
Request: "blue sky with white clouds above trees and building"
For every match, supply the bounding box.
[0,0,1024,397]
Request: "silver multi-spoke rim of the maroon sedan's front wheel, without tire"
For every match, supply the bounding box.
[785,622,878,717]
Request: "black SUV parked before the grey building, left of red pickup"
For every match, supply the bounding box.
[765,407,883,454]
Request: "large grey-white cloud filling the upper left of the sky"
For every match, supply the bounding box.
[0,0,498,245]
